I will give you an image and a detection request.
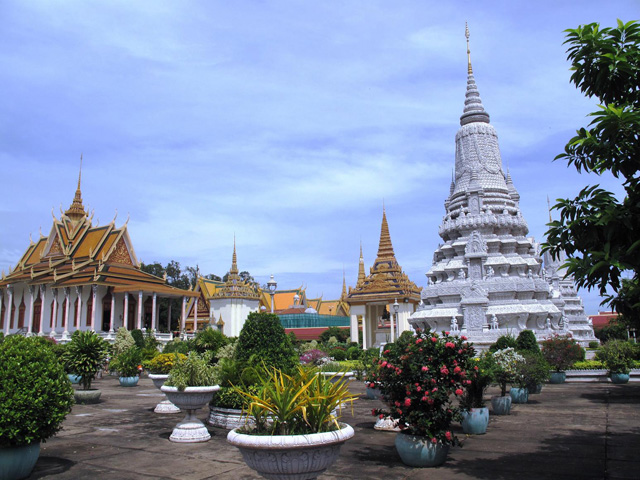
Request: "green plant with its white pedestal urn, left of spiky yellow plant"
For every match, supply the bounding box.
[160,352,220,443]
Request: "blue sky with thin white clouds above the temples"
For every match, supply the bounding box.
[0,0,640,314]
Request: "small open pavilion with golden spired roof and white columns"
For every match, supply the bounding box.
[347,209,421,349]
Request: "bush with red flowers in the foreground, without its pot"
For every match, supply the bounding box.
[372,329,475,445]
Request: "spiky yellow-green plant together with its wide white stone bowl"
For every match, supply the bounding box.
[227,366,356,479]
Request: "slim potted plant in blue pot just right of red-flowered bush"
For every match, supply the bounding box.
[460,352,495,435]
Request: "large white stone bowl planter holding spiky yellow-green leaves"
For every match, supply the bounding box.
[227,423,354,480]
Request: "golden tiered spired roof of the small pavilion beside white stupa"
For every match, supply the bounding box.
[347,209,420,305]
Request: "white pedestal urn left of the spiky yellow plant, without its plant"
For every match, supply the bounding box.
[160,385,220,443]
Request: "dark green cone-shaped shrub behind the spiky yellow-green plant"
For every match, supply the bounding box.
[236,312,298,372]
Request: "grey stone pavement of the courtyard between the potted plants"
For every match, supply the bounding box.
[29,377,640,480]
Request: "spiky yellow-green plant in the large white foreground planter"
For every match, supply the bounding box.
[234,366,357,435]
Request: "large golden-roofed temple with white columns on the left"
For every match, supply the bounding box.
[0,172,194,341]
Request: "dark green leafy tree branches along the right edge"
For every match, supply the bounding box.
[543,20,640,328]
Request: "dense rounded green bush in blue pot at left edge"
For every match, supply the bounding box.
[0,335,73,480]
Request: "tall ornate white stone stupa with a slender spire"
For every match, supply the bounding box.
[409,29,567,349]
